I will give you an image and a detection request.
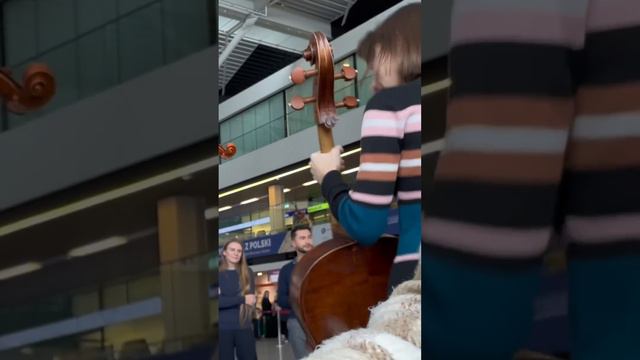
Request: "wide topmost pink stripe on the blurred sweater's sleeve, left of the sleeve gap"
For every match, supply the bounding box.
[451,10,585,48]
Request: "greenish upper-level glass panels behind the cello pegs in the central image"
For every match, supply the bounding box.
[220,55,373,162]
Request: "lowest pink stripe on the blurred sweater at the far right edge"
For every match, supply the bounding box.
[565,214,640,244]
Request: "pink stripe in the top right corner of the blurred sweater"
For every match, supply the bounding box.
[587,0,640,31]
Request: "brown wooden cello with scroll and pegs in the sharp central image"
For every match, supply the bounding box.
[289,32,397,348]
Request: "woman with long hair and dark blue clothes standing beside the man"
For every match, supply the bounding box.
[218,240,256,360]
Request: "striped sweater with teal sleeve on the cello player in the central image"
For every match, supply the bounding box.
[322,80,422,287]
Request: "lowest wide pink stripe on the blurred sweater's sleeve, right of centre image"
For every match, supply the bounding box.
[422,218,551,257]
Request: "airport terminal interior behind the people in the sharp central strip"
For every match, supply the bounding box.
[218,1,442,360]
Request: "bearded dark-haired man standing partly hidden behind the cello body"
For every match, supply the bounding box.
[275,225,313,360]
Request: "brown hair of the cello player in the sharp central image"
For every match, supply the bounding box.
[357,3,422,83]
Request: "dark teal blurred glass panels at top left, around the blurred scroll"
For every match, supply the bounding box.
[2,0,211,129]
